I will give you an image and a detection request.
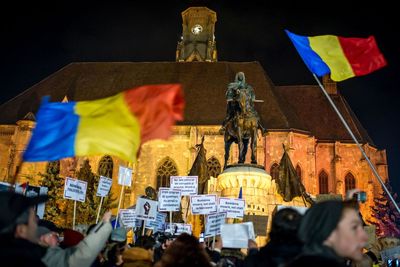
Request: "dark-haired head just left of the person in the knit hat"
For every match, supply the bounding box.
[269,208,303,243]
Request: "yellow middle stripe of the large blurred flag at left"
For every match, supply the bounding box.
[75,93,140,162]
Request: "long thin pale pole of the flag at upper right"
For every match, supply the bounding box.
[313,73,400,215]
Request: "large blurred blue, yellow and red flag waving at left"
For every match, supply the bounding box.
[23,84,184,162]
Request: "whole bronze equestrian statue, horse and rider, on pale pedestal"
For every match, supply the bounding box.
[220,72,267,169]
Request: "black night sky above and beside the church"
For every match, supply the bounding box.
[0,0,400,196]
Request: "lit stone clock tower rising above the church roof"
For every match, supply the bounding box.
[176,7,217,62]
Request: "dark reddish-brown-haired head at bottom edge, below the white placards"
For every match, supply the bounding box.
[156,233,211,267]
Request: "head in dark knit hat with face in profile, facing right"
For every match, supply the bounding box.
[298,200,368,260]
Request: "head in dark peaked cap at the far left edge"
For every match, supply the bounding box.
[0,191,47,243]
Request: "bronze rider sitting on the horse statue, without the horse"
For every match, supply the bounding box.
[219,72,267,136]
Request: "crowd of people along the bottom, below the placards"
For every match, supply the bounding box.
[0,191,388,267]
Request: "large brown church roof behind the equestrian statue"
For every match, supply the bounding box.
[0,62,372,144]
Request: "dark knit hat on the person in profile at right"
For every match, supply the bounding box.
[298,200,343,246]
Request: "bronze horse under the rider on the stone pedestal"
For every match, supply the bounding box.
[224,89,260,169]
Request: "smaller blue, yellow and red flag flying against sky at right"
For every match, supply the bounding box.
[286,30,386,81]
